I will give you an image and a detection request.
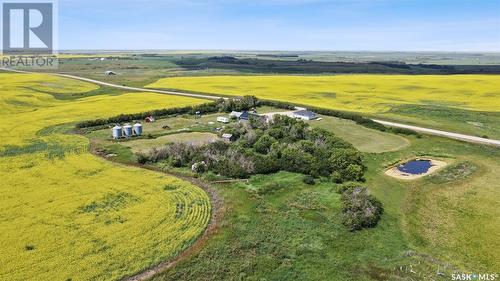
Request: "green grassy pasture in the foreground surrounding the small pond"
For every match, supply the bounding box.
[154,132,500,280]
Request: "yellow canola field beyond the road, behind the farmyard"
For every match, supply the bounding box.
[148,74,500,113]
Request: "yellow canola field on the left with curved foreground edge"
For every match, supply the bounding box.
[0,73,211,280]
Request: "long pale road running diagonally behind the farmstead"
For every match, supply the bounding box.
[0,68,500,146]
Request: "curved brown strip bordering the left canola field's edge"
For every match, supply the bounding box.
[90,142,226,281]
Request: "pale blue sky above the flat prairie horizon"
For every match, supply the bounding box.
[59,0,500,52]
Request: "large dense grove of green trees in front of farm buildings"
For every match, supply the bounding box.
[137,116,366,182]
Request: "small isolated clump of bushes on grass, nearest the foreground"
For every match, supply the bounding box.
[338,184,384,231]
